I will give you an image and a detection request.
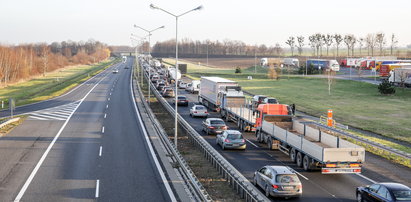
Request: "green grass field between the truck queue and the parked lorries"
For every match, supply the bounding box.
[163,59,411,143]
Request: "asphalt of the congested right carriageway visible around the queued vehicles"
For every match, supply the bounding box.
[163,76,411,201]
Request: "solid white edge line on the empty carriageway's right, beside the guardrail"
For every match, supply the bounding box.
[130,69,177,202]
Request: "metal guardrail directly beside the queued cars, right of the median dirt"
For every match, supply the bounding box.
[144,68,270,202]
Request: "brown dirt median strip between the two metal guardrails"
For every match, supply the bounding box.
[142,79,244,201]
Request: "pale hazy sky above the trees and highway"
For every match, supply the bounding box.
[0,0,411,46]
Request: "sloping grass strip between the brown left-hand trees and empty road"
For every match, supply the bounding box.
[0,59,119,108]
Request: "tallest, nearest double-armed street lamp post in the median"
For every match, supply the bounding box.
[150,4,203,147]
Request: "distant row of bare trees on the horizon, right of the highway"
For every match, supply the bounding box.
[150,32,404,57]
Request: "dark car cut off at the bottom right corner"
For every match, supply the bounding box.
[356,182,411,202]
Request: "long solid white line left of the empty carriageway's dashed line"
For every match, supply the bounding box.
[14,65,107,202]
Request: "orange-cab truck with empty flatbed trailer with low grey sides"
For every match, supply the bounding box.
[256,104,365,174]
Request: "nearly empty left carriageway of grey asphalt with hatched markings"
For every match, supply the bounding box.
[0,59,175,201]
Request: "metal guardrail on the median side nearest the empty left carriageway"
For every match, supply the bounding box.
[134,69,212,201]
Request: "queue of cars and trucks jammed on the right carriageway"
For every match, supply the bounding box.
[139,56,411,201]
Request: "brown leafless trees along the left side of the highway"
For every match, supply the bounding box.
[0,40,110,85]
